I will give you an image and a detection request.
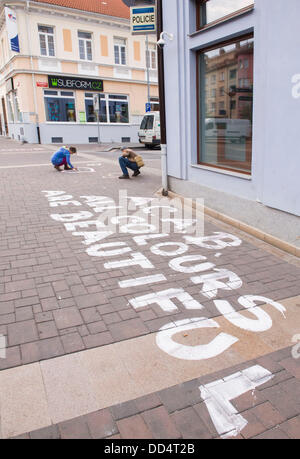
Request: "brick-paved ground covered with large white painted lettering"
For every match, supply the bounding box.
[0,138,300,439]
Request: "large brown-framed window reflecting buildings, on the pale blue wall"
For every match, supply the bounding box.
[198,35,254,174]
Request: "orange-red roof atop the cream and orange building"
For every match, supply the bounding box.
[33,0,130,19]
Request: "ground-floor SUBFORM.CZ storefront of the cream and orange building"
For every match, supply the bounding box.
[2,71,158,144]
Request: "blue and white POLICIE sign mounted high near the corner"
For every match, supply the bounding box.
[130,6,156,35]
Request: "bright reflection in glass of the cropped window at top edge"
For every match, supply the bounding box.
[201,0,254,26]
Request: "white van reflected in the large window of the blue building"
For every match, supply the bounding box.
[205,118,251,143]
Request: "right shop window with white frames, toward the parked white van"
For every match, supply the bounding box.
[85,93,129,123]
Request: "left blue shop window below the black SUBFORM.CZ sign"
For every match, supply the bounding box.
[44,91,76,122]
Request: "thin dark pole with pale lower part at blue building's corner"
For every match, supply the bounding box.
[157,0,168,196]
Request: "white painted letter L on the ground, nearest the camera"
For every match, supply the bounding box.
[199,365,273,438]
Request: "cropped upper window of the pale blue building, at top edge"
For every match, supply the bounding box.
[197,0,254,30]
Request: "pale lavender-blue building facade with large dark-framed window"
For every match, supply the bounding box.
[163,0,300,216]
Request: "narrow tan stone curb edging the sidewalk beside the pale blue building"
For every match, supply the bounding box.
[156,188,300,258]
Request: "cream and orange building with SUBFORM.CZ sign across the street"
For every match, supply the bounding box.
[0,0,158,144]
